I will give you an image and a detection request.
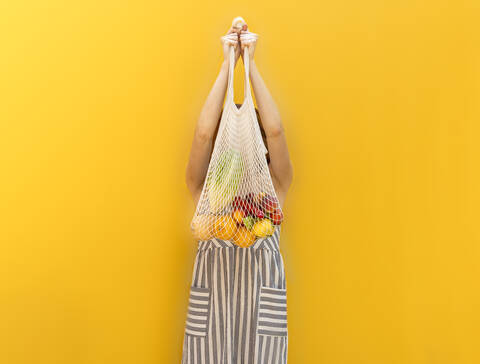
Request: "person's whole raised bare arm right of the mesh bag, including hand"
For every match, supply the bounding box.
[241,31,293,198]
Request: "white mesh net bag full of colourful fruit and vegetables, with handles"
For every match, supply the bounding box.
[190,24,283,247]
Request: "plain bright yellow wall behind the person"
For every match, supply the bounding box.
[0,0,480,364]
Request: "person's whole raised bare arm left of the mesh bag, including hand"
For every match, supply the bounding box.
[185,28,240,203]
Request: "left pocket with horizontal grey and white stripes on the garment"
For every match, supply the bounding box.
[185,286,211,336]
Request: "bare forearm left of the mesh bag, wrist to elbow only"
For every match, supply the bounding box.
[197,61,229,138]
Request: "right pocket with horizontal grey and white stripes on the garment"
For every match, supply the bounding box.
[257,286,287,336]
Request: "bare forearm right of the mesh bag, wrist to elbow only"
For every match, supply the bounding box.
[250,60,283,137]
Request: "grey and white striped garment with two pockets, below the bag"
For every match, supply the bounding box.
[182,225,288,364]
